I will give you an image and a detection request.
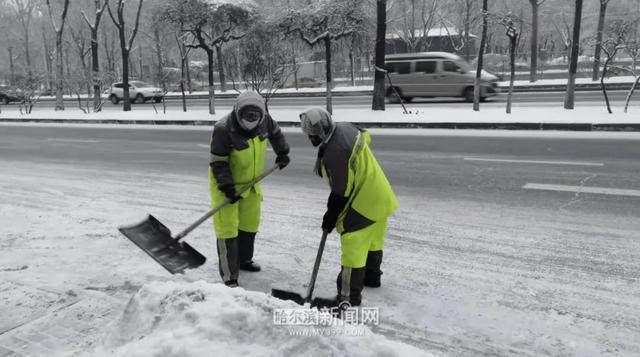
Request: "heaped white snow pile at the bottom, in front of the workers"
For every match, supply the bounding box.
[91,281,429,357]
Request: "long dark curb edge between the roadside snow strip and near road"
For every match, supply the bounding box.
[5,118,640,132]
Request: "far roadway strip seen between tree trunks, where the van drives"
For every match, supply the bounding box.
[11,91,638,111]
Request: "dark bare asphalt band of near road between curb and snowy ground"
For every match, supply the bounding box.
[0,125,640,218]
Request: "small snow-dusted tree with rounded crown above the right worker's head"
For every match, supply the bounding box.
[280,0,364,113]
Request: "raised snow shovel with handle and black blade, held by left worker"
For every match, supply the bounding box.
[118,165,278,274]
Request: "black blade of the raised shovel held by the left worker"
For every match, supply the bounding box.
[118,215,207,274]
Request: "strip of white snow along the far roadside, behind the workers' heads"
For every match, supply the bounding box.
[0,102,640,124]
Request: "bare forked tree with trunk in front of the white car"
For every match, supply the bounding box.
[107,0,144,112]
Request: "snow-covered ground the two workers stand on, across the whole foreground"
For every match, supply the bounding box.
[0,126,640,356]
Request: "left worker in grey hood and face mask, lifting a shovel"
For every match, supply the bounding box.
[209,92,289,287]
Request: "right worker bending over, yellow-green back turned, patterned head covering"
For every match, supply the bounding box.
[300,107,398,306]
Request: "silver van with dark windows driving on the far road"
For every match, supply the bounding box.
[385,52,500,103]
